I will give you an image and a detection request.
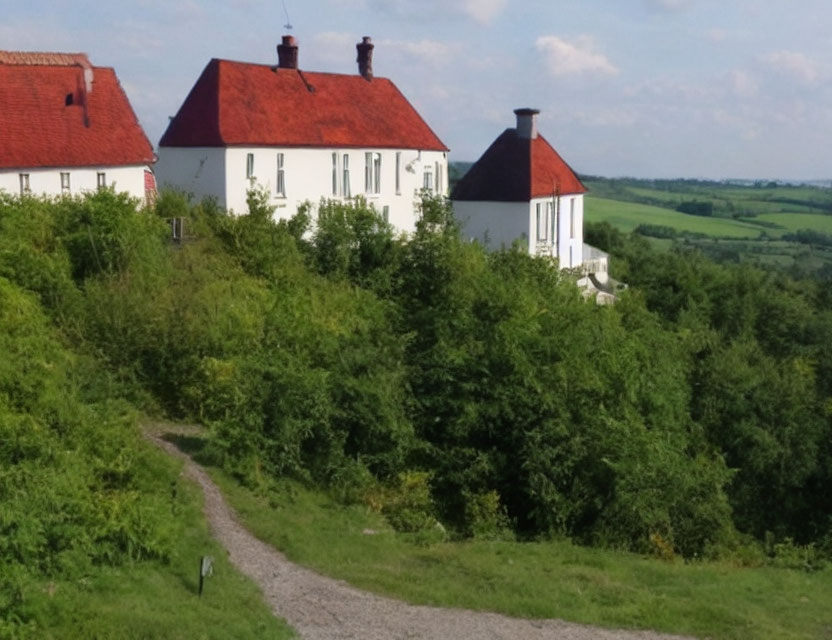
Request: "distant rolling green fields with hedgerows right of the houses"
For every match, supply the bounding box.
[584,178,832,275]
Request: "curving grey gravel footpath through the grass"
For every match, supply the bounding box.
[146,424,696,640]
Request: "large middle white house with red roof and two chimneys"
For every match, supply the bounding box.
[156,36,448,231]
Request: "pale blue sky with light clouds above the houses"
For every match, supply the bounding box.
[6,0,832,180]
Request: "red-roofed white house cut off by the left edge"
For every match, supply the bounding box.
[0,51,155,199]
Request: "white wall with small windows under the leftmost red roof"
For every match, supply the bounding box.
[0,165,150,200]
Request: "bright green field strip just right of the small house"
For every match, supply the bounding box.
[584,196,762,238]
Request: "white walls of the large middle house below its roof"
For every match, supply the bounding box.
[156,147,448,232]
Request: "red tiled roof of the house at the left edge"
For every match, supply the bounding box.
[0,51,154,169]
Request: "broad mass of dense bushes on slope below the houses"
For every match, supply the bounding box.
[0,192,832,584]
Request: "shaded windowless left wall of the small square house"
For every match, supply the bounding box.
[453,200,529,249]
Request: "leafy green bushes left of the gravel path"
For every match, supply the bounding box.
[0,277,174,636]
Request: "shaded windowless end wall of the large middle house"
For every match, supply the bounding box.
[155,147,225,207]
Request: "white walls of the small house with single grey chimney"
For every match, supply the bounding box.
[453,194,584,269]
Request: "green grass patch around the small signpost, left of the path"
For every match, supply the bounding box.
[13,445,295,640]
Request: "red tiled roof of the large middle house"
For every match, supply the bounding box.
[159,59,448,151]
